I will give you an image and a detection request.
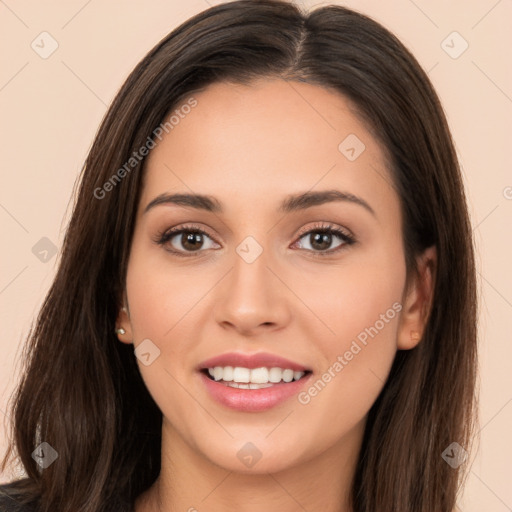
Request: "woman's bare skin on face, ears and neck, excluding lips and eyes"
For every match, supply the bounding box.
[117,79,435,512]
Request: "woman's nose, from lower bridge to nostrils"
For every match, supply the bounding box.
[215,243,291,336]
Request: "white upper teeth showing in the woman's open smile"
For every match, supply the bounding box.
[208,366,305,389]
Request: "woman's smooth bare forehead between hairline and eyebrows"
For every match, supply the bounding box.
[141,80,398,219]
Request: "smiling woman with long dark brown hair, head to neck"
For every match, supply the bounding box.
[3,0,476,512]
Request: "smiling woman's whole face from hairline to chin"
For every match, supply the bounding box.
[118,80,430,473]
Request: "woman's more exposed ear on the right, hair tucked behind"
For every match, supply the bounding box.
[397,246,437,350]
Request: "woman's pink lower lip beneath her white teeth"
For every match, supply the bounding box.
[200,372,312,412]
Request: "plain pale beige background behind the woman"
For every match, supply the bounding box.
[0,0,512,512]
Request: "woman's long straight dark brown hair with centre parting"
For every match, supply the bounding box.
[2,0,477,512]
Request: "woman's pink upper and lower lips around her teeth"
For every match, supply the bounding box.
[198,352,311,412]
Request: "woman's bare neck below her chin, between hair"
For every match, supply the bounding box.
[135,418,364,512]
